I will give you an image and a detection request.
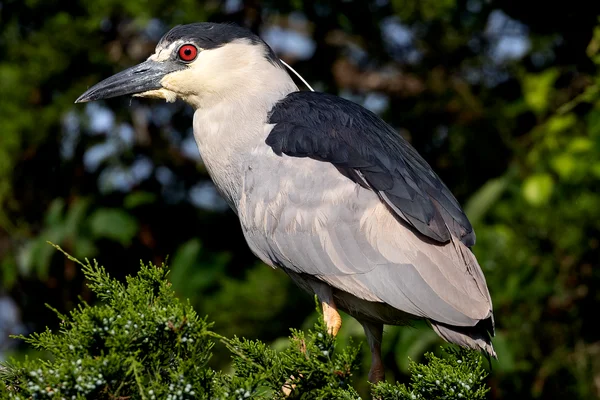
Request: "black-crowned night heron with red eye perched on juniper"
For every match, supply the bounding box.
[76,23,495,381]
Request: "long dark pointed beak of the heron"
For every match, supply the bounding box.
[75,60,185,103]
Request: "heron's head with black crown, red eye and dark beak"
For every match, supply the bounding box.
[75,23,289,108]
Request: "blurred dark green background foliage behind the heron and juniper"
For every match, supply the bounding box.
[0,0,600,399]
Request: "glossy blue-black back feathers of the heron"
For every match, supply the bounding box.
[266,91,475,246]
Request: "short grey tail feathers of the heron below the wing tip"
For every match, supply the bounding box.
[430,320,498,359]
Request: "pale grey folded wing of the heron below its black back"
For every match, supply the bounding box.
[239,152,492,326]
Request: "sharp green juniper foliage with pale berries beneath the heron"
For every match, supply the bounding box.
[0,252,486,400]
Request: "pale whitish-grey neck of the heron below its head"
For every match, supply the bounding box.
[194,65,298,211]
